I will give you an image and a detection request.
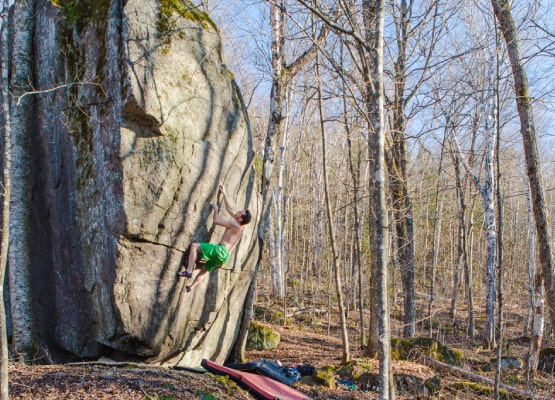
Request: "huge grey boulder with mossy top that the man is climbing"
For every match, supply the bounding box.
[30,0,260,365]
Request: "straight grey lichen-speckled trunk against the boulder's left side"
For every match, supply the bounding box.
[8,0,36,361]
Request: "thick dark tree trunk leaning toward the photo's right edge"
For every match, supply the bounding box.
[491,0,555,329]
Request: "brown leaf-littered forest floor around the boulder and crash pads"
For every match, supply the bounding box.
[10,302,555,400]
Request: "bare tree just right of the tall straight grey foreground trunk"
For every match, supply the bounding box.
[386,0,445,337]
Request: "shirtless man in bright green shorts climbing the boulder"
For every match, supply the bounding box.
[177,185,252,292]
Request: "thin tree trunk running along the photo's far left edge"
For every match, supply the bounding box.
[0,0,11,400]
